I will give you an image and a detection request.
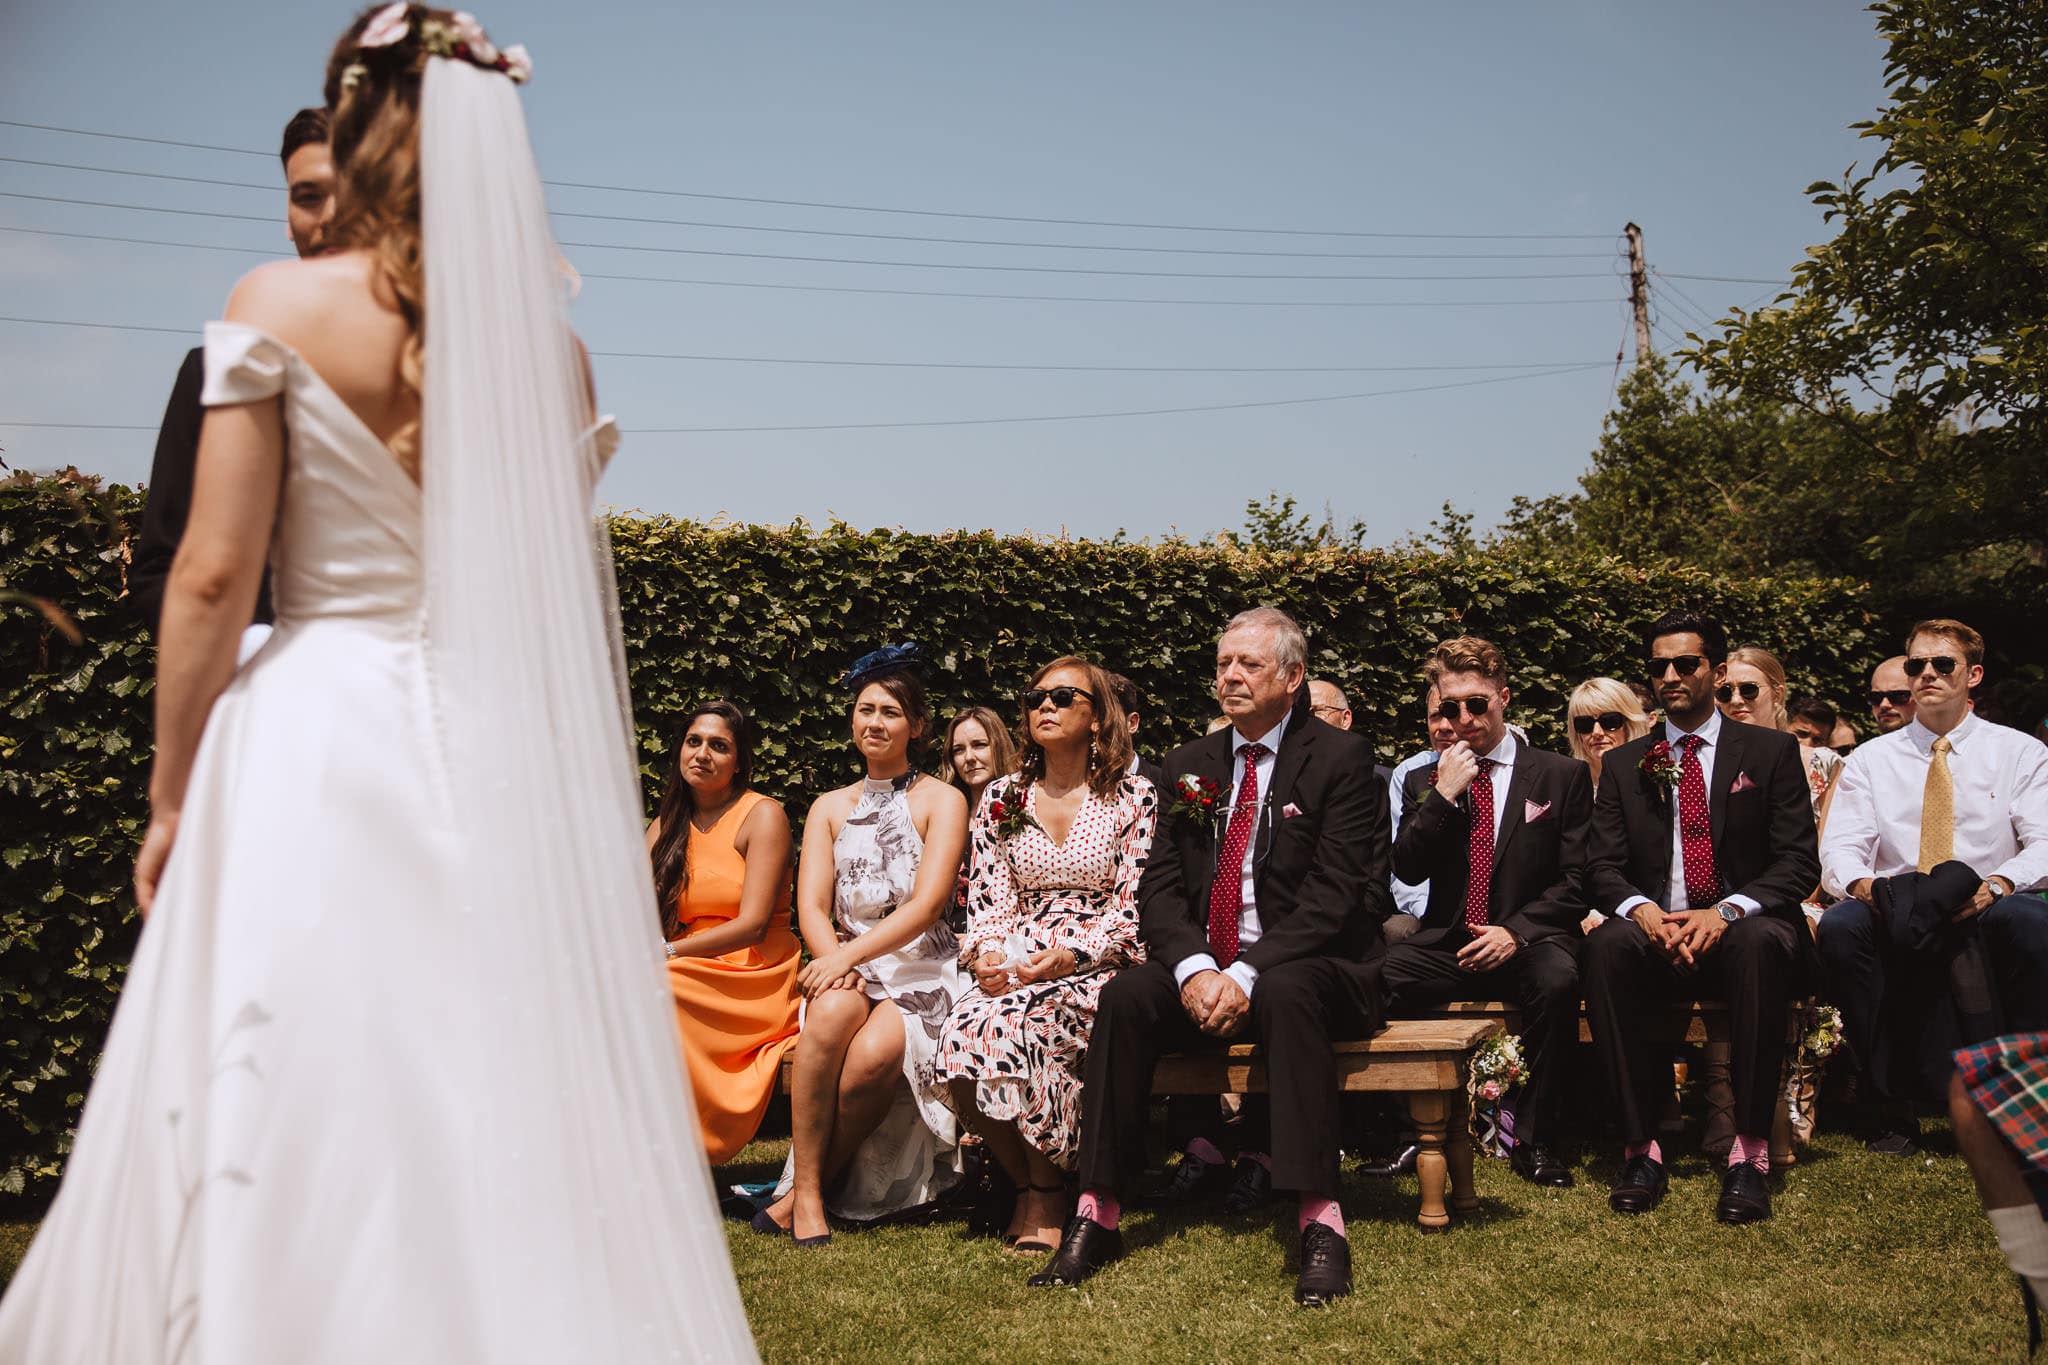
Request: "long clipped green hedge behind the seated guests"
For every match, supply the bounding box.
[0,475,1896,1197]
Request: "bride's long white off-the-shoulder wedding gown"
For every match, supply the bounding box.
[0,323,743,1365]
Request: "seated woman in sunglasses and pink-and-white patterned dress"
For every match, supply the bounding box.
[938,657,1159,1252]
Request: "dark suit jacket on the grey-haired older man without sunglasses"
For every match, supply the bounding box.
[1139,688,1393,972]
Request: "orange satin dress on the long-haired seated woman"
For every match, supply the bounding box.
[668,792,801,1164]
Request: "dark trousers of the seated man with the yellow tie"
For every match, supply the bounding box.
[1815,896,2048,1101]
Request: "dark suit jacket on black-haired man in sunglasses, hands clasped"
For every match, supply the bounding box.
[1585,716,1821,948]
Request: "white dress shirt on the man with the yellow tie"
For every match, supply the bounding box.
[1821,710,2048,898]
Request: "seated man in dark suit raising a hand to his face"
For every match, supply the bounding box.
[1380,636,1593,1187]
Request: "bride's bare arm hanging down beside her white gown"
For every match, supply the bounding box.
[135,323,285,915]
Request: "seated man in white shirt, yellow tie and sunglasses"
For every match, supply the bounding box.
[1819,620,2048,1156]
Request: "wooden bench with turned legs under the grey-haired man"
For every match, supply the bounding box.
[1153,1017,1501,1232]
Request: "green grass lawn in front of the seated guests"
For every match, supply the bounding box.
[0,1134,2025,1365]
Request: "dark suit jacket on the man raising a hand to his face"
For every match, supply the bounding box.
[1395,741,1593,943]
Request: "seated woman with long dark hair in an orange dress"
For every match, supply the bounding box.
[647,700,799,1164]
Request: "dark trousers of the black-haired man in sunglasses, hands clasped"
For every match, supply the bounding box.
[1579,915,1800,1144]
